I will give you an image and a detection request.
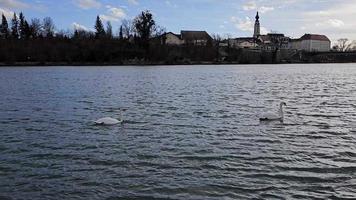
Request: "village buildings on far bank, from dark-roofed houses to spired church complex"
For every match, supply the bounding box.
[160,12,331,52]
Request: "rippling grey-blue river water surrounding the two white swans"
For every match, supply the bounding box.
[0,64,356,199]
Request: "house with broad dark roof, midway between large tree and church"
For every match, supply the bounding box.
[181,31,213,46]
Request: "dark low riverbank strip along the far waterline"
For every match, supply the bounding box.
[0,49,356,67]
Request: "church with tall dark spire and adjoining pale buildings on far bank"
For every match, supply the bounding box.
[229,12,331,52]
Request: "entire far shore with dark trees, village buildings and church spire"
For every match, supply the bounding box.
[0,10,356,66]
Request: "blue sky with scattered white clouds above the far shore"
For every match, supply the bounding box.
[0,0,356,41]
